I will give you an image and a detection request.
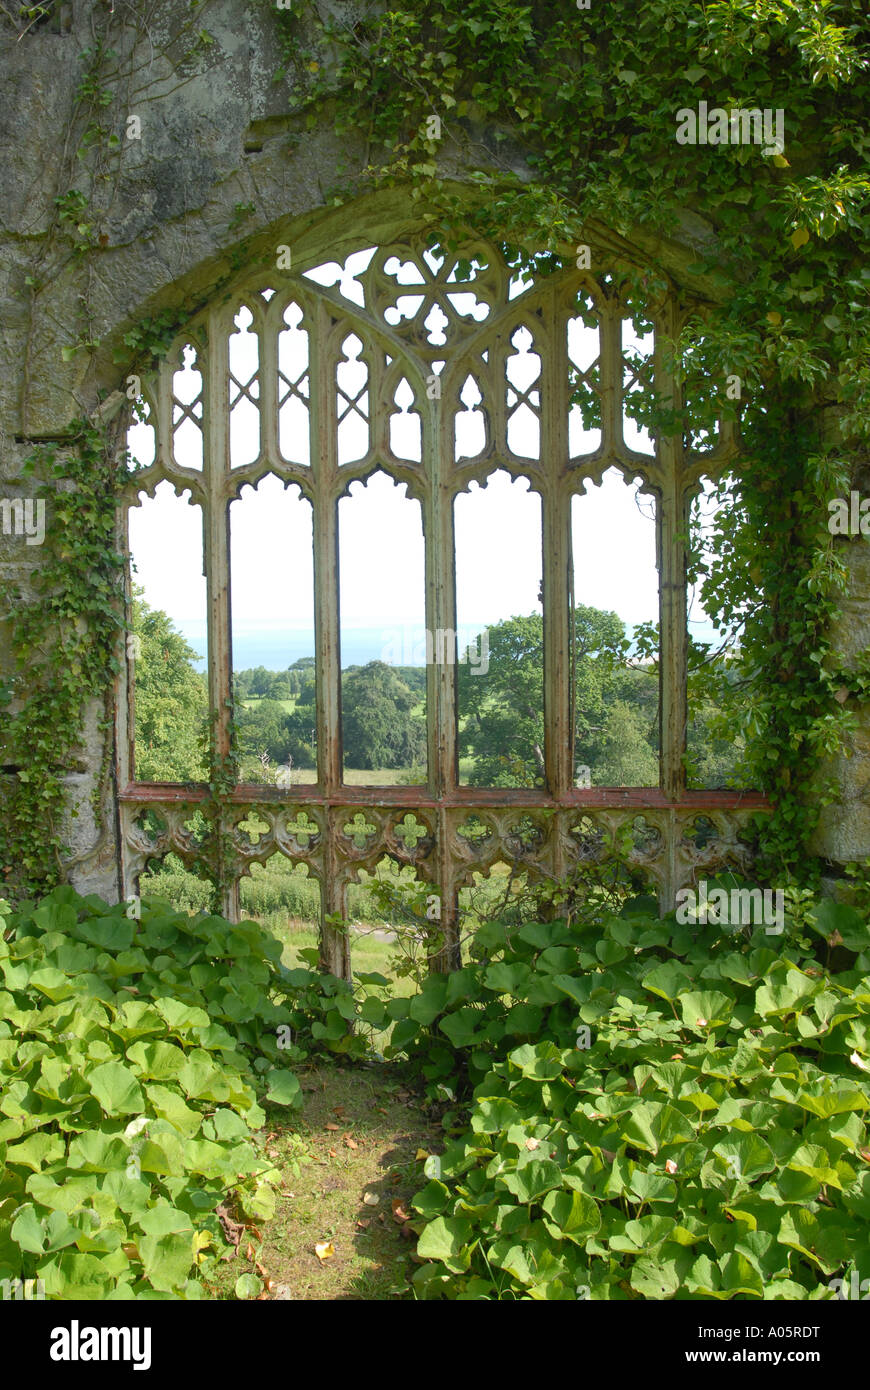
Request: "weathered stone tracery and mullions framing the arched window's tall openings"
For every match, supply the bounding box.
[118,233,763,974]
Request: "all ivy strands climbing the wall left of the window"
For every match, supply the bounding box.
[0,0,223,897]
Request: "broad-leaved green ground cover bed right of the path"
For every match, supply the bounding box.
[388,894,870,1300]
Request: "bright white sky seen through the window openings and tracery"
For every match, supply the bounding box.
[128,252,712,670]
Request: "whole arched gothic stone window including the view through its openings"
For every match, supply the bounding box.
[120,242,760,973]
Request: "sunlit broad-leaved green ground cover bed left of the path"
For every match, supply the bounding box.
[0,888,302,1300]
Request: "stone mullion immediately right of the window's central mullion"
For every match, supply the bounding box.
[538,293,574,799]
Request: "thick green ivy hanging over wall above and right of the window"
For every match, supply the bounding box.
[269,0,870,877]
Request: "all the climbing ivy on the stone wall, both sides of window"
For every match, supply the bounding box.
[0,0,870,887]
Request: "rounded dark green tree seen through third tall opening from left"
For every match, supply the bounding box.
[342,662,425,770]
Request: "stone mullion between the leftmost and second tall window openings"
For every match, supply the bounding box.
[203,310,239,922]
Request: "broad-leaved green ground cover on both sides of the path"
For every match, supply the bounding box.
[0,884,870,1301]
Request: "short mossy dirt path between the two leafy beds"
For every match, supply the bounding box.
[244,1065,443,1301]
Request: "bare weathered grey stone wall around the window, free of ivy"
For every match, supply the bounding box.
[0,0,870,899]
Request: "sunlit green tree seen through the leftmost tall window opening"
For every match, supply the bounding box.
[132,589,208,781]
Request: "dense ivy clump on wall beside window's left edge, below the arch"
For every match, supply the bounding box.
[0,420,125,895]
